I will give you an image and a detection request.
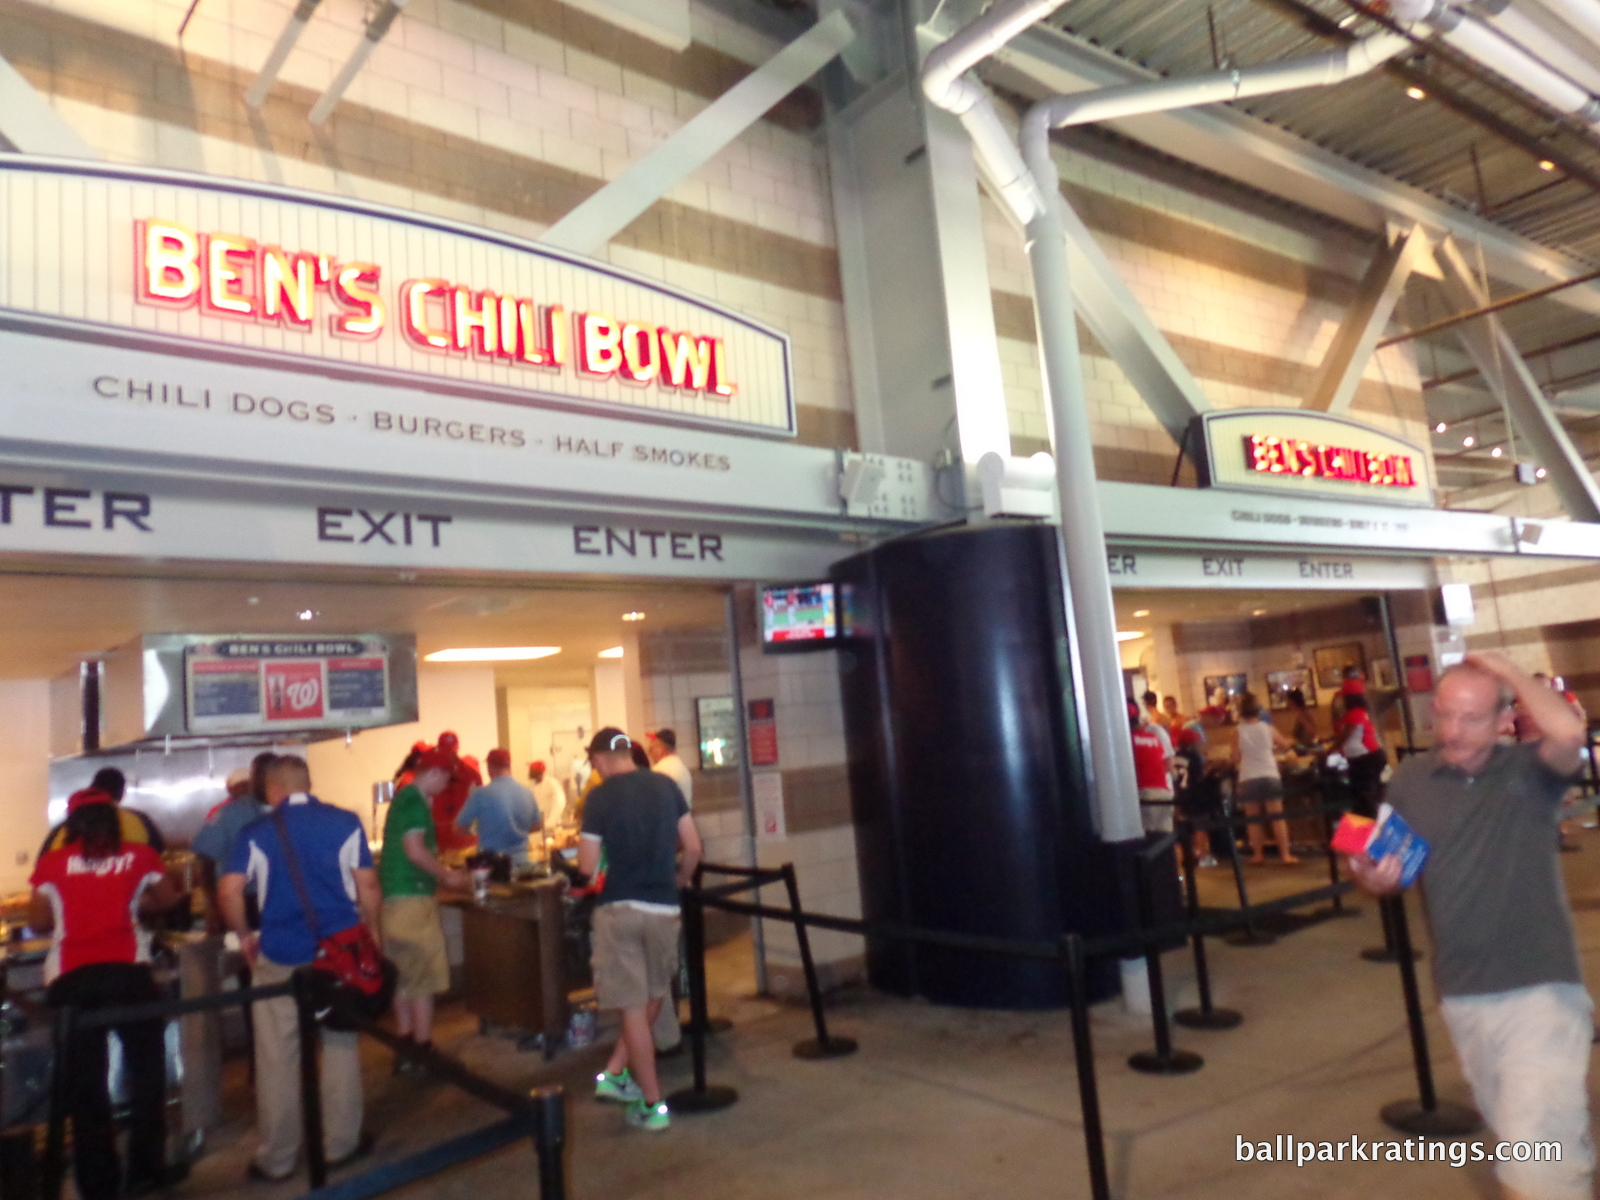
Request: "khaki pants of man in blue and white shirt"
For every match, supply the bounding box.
[251,958,362,1178]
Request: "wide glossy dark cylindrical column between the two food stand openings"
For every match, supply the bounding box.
[834,522,1122,1008]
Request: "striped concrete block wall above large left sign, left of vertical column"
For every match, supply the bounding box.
[0,0,854,446]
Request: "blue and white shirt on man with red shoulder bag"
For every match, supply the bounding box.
[224,792,373,966]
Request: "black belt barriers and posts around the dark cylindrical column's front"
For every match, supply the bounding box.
[681,838,1477,1200]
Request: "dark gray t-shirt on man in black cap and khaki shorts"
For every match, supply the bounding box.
[582,771,690,907]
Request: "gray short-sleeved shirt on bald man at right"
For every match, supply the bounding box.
[1389,742,1582,995]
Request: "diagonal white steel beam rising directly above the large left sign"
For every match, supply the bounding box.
[539,11,856,254]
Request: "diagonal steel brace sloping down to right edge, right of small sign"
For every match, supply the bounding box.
[1434,238,1600,522]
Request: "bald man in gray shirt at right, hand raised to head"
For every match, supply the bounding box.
[1350,653,1595,1200]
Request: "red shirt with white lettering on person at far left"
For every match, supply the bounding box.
[29,842,166,982]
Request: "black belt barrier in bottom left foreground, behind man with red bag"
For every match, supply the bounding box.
[43,973,566,1200]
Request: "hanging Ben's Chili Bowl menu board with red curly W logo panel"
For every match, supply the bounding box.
[184,637,389,734]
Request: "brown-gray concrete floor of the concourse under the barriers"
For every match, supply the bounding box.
[165,830,1600,1200]
